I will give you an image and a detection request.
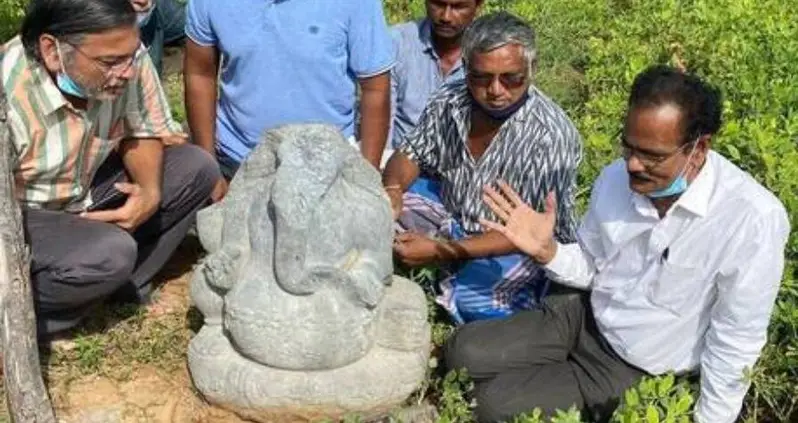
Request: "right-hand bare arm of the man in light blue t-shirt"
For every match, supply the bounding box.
[359,72,391,169]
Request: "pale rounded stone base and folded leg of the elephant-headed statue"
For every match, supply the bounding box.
[188,277,430,422]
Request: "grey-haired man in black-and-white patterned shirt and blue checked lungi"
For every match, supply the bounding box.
[383,13,582,322]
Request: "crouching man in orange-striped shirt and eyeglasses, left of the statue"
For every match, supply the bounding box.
[0,0,220,335]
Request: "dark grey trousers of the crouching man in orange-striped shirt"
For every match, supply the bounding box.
[23,144,220,336]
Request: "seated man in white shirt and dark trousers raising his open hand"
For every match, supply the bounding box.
[446,67,790,423]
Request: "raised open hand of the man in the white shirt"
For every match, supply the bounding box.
[480,181,557,264]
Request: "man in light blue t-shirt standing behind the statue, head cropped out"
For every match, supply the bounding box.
[185,0,394,199]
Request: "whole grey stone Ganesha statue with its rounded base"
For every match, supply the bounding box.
[188,125,430,421]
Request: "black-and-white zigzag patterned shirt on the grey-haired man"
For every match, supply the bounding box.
[399,81,582,243]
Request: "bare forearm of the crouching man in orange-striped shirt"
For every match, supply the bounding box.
[119,139,164,198]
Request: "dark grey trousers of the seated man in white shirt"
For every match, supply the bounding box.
[445,293,645,422]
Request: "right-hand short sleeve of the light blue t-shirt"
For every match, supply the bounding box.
[348,0,395,78]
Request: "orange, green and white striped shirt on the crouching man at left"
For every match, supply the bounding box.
[0,37,186,210]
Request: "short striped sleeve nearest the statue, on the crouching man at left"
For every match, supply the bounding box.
[124,47,186,143]
